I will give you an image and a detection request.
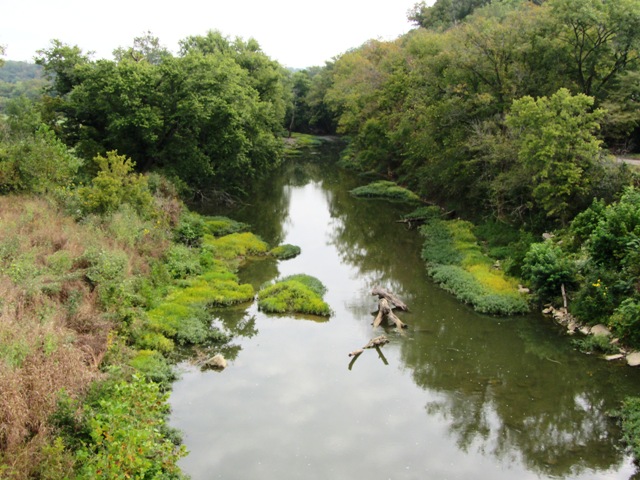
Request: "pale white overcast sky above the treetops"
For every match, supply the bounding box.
[0,0,422,68]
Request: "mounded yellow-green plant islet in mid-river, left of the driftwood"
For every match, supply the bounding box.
[258,274,331,317]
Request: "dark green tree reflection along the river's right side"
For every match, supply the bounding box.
[306,150,639,476]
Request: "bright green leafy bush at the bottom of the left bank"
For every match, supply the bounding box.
[76,377,186,479]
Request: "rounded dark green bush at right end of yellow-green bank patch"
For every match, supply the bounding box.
[522,240,576,301]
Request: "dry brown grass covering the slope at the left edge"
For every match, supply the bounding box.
[0,196,114,478]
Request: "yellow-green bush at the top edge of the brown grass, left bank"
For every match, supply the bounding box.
[77,151,153,215]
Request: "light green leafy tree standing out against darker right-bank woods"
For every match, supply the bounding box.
[506,88,604,224]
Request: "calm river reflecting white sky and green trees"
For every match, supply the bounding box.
[170,141,640,480]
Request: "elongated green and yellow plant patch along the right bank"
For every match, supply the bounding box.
[420,220,529,315]
